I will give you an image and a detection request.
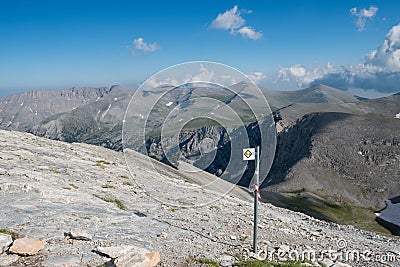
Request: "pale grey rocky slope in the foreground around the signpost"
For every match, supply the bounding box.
[0,131,400,267]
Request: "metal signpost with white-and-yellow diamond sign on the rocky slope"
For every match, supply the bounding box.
[243,146,261,253]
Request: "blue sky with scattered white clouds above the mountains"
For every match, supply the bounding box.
[0,0,400,96]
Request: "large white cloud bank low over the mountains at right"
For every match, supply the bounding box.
[274,23,400,97]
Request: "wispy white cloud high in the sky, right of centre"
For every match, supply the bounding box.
[210,6,263,40]
